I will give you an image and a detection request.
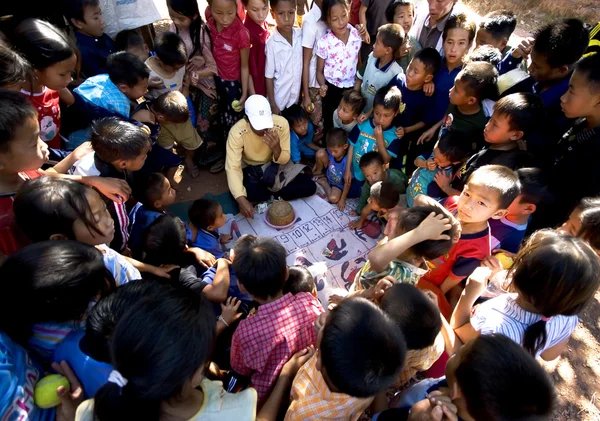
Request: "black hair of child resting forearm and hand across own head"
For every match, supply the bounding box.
[397,205,456,260]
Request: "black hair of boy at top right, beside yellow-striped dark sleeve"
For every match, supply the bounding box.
[533,19,589,68]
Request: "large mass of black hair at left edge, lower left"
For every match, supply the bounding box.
[0,241,116,344]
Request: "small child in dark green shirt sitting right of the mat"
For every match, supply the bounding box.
[350,151,408,229]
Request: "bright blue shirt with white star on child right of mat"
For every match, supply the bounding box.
[348,118,400,181]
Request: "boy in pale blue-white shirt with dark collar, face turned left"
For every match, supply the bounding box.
[354,24,404,123]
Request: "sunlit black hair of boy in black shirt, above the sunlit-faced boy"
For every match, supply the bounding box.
[494,92,545,138]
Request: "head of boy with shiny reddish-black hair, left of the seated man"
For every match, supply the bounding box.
[90,117,150,171]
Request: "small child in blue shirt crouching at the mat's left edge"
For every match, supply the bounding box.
[188,198,231,259]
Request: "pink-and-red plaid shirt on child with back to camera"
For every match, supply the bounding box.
[231,292,323,407]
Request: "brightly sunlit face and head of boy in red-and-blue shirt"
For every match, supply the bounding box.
[457,165,521,223]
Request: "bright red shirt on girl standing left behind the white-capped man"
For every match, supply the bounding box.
[206,8,250,81]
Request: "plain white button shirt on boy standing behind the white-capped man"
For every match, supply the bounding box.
[265,28,302,110]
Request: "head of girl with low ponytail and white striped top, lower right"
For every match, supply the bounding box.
[509,230,600,356]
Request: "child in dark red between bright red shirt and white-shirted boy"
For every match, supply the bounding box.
[242,0,269,96]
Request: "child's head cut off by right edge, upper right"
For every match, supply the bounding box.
[560,54,600,118]
